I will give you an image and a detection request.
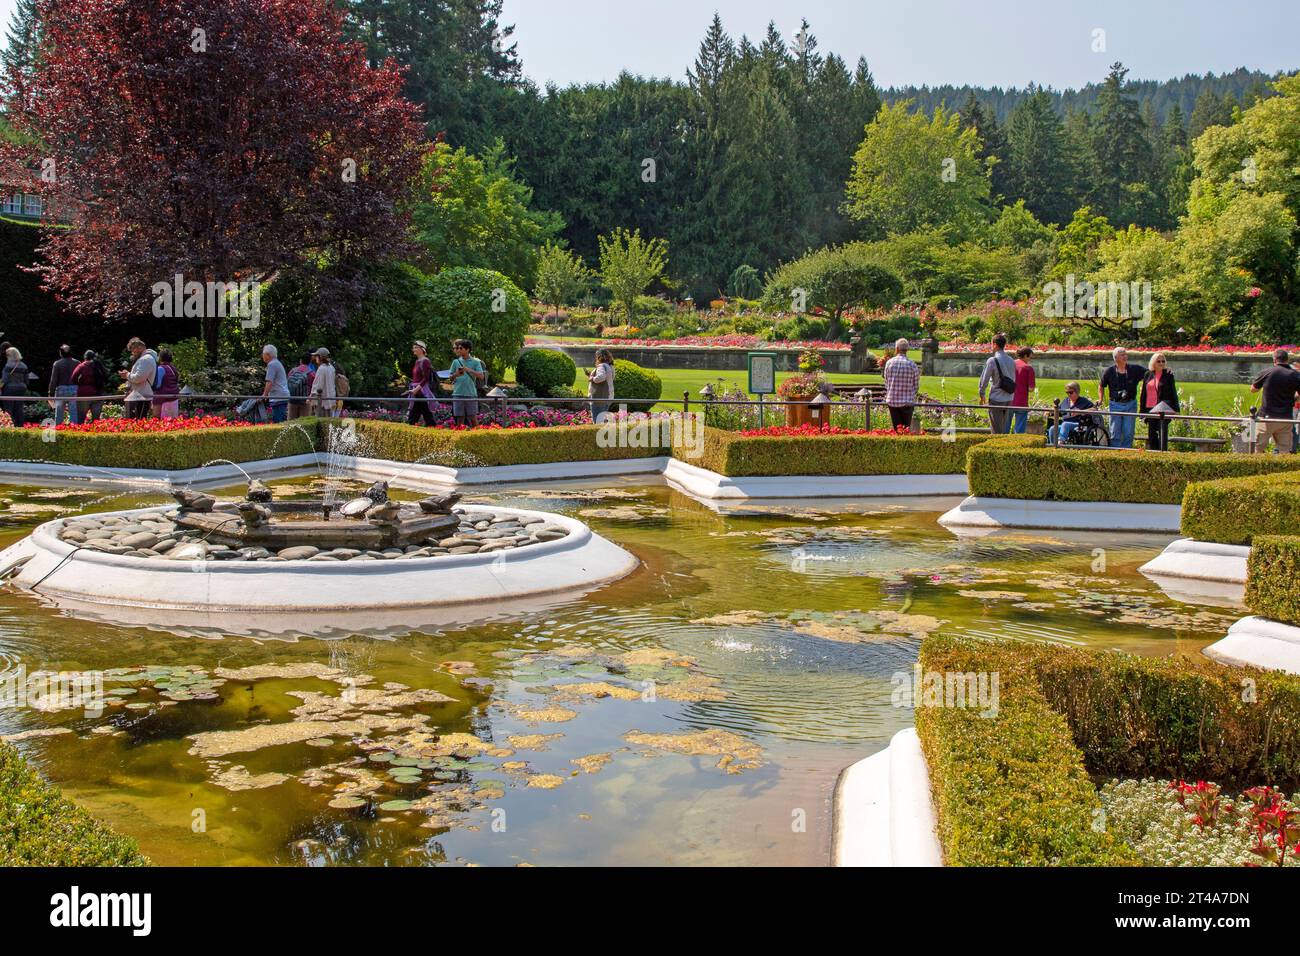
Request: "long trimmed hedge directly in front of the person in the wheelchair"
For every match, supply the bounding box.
[967,438,1300,505]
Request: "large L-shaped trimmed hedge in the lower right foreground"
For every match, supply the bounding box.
[917,636,1300,866]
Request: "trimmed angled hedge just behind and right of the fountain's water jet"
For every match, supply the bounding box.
[356,420,667,468]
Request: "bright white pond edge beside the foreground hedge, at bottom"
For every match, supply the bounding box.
[831,727,944,866]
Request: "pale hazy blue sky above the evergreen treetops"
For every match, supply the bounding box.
[0,0,1300,88]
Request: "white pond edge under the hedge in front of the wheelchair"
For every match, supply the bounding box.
[939,496,1182,533]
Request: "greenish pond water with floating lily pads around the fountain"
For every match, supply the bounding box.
[0,477,1239,865]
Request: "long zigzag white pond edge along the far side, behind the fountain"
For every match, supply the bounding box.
[0,451,967,501]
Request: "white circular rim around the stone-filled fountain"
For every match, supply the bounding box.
[0,506,638,613]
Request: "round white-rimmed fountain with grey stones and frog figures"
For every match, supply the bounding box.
[0,477,637,620]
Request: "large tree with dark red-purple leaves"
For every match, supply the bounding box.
[4,0,428,360]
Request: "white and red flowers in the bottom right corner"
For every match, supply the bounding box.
[1100,778,1300,866]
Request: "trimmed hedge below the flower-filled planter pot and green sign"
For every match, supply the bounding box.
[673,428,1041,477]
